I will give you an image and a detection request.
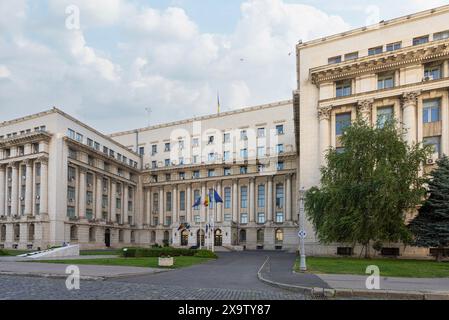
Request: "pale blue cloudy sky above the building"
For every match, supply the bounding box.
[0,0,449,133]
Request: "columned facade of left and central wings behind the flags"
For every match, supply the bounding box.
[0,101,298,250]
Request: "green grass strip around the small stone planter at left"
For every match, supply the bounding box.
[34,257,211,269]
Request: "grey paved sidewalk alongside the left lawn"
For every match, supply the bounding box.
[0,261,167,280]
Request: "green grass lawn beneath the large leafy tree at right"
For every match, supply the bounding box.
[295,257,449,278]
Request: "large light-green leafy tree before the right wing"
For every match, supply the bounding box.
[305,118,430,258]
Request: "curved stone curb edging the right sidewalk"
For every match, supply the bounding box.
[257,257,449,300]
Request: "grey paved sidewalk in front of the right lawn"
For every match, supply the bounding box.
[260,254,449,293]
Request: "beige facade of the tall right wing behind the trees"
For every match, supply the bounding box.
[294,6,449,256]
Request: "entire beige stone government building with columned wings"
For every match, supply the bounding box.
[0,6,449,256]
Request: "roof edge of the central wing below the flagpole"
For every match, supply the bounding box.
[109,99,293,137]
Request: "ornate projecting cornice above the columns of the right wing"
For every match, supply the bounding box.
[310,39,449,85]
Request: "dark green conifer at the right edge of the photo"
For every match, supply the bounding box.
[410,156,449,261]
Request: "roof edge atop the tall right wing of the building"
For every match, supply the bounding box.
[296,5,449,50]
